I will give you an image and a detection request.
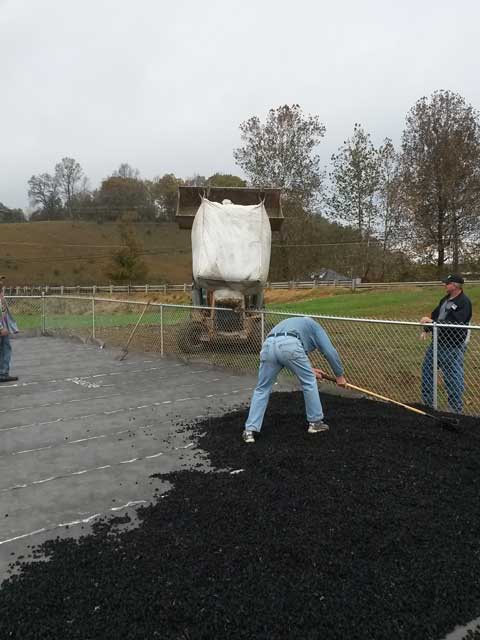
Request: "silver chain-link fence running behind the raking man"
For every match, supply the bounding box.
[8,296,480,415]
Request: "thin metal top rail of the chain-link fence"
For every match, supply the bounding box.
[6,295,480,331]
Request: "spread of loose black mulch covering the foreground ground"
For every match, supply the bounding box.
[0,393,480,640]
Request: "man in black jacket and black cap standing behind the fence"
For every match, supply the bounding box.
[420,274,472,413]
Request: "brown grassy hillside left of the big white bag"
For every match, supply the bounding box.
[0,221,192,285]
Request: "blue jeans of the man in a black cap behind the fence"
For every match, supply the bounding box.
[422,343,466,413]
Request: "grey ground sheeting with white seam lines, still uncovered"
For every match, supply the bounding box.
[0,337,270,580]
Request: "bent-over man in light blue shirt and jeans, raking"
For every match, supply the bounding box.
[243,317,346,443]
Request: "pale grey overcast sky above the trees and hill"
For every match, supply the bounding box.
[0,0,480,208]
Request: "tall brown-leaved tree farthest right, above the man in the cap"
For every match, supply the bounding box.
[402,91,480,274]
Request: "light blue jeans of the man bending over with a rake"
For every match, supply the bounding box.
[245,336,323,431]
